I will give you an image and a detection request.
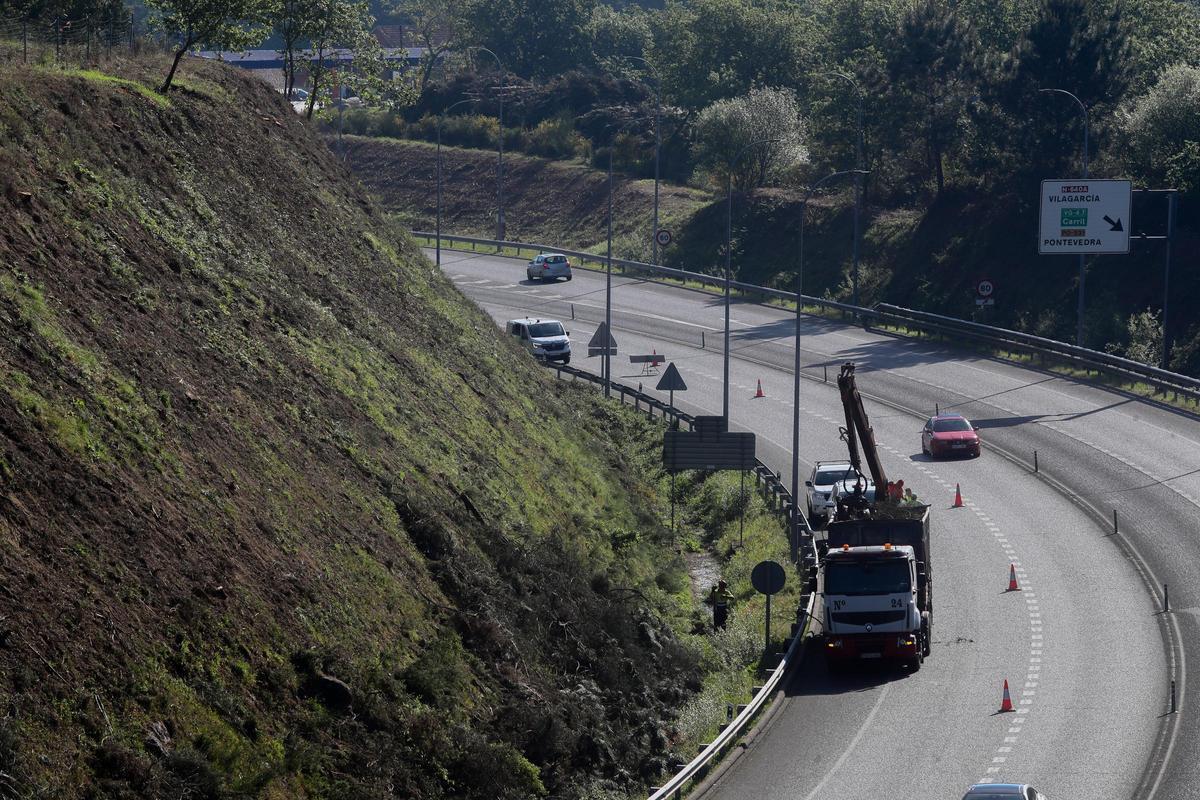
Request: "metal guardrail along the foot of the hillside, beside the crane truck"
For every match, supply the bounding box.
[552,364,820,800]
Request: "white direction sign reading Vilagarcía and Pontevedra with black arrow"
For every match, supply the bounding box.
[1038,178,1132,255]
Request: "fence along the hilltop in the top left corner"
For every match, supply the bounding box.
[0,14,142,66]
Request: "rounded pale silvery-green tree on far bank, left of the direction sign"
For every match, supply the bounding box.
[696,89,808,191]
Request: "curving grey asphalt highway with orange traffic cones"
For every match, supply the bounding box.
[432,251,1200,800]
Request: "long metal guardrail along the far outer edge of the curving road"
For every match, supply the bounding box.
[422,230,1200,403]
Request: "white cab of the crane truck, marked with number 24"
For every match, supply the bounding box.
[818,543,925,669]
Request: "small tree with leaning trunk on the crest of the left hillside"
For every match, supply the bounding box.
[146,0,275,95]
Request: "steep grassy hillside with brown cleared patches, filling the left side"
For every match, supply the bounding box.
[0,61,739,798]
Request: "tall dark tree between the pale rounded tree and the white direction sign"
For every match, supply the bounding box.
[887,0,974,194]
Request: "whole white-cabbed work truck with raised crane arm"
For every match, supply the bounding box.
[817,363,934,670]
